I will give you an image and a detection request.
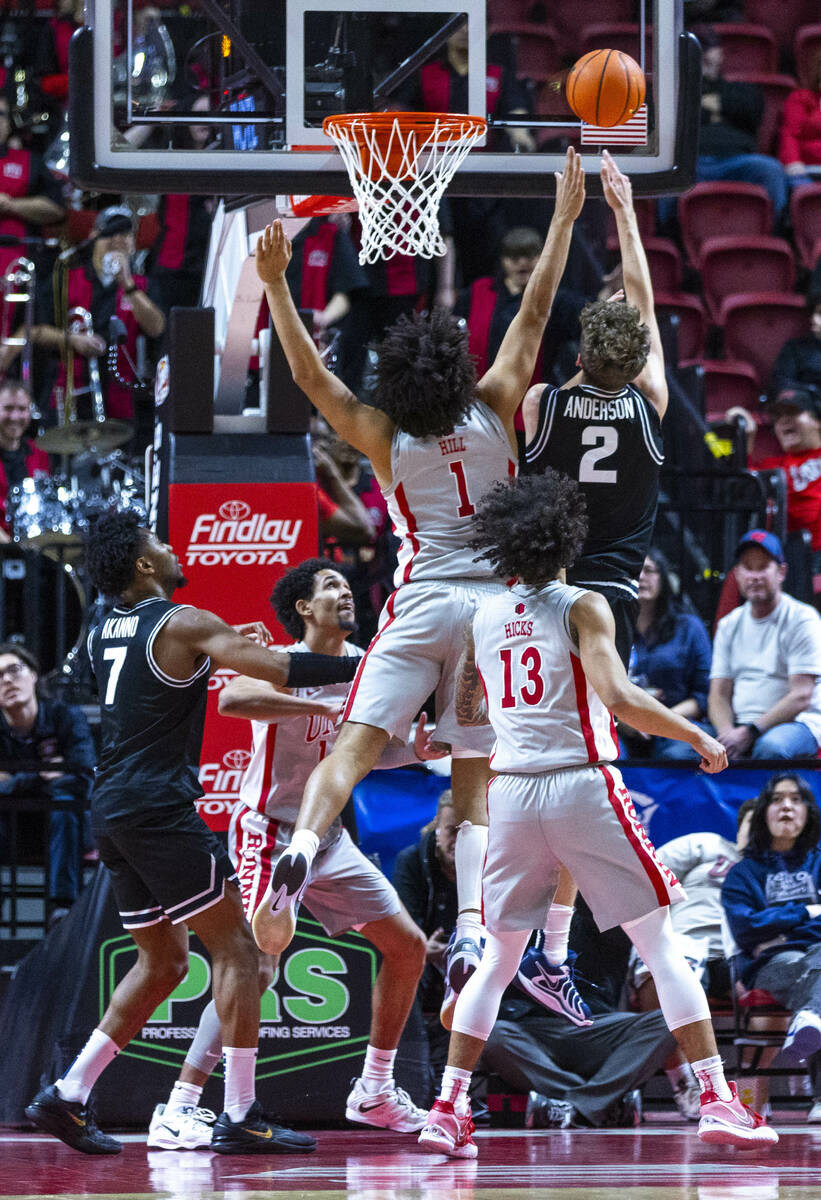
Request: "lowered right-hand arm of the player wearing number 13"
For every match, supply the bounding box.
[570,592,727,774]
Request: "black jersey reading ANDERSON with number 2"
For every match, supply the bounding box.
[525,384,664,598]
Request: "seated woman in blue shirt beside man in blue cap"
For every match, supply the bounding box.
[618,550,711,762]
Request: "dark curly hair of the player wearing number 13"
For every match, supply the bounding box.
[468,468,587,588]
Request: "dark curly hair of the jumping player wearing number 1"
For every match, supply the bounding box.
[373,308,477,438]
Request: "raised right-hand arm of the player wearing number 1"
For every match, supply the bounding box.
[478,146,585,421]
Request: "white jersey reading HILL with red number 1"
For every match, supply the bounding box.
[384,400,516,587]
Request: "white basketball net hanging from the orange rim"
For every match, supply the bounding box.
[322,113,487,265]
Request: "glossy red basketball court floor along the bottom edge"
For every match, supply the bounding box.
[0,1115,821,1200]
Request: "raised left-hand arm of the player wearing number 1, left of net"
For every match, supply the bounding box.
[257,221,394,487]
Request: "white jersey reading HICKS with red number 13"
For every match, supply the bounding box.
[473,581,618,774]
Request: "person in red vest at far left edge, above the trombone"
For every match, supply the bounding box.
[0,94,65,275]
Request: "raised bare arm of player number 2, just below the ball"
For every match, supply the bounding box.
[601,150,667,416]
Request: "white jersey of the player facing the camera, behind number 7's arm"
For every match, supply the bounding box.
[240,642,362,833]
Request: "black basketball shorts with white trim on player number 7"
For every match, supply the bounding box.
[95,805,236,929]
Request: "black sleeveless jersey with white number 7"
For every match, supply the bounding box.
[88,598,211,824]
